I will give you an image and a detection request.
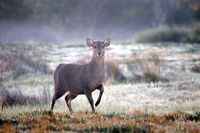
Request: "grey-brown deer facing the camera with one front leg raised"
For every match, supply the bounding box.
[51,38,111,113]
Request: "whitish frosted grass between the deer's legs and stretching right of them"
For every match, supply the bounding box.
[48,84,200,113]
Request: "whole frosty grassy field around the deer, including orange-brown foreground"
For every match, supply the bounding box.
[0,42,200,133]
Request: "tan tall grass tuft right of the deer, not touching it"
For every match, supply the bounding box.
[128,52,168,83]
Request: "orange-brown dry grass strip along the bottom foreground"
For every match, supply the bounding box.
[0,110,200,133]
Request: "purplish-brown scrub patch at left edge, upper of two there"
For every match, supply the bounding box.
[0,49,50,82]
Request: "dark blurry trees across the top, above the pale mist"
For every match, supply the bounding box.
[0,0,200,28]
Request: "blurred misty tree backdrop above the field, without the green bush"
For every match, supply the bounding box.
[0,0,200,43]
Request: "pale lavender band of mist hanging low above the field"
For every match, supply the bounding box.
[0,20,133,43]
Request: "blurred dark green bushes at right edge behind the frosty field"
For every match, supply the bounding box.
[136,23,200,43]
